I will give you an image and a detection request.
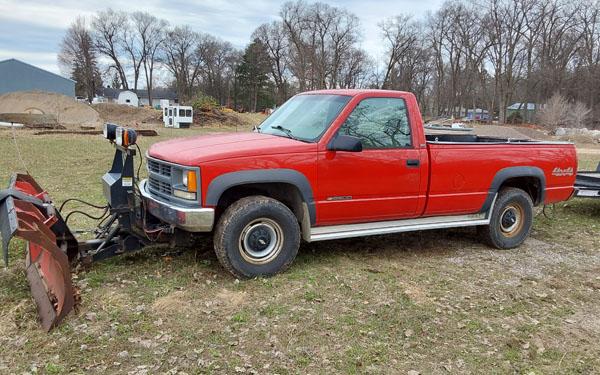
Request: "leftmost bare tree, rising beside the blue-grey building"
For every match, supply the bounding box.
[58,17,102,103]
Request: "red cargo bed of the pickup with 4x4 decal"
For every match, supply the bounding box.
[425,138,577,216]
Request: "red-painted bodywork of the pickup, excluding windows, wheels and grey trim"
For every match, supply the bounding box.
[149,90,577,225]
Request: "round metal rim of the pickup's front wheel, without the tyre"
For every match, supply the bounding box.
[239,218,283,264]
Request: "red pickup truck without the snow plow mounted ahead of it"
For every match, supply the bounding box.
[140,90,577,277]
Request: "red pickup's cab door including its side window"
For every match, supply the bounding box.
[316,97,426,225]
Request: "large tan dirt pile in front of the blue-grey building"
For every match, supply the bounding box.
[0,91,102,128]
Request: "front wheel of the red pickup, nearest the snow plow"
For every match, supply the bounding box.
[214,196,300,278]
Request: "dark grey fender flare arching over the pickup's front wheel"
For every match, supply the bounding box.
[206,168,317,225]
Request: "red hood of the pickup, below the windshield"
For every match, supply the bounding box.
[148,132,317,166]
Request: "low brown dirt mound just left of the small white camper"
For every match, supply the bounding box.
[93,103,162,128]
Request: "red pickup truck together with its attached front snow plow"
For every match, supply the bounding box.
[0,90,583,330]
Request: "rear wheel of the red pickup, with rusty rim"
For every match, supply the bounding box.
[478,188,533,249]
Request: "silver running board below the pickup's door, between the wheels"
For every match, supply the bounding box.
[309,212,493,242]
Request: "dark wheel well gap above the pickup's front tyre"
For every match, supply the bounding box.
[215,182,310,225]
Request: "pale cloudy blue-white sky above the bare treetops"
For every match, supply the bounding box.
[0,0,442,78]
